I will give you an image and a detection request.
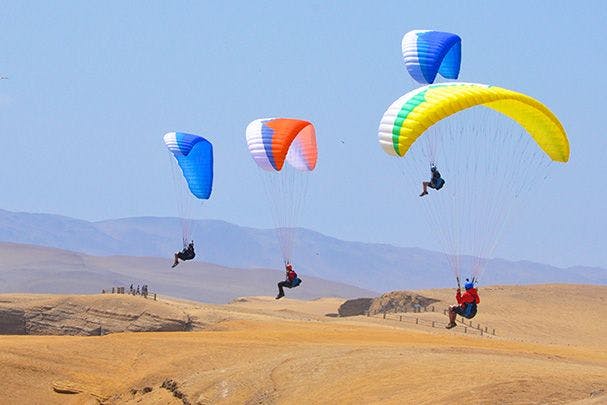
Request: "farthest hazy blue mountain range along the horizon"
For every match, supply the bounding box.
[0,210,607,291]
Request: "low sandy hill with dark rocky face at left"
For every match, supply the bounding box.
[0,294,343,336]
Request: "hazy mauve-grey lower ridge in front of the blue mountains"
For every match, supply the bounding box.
[0,243,377,303]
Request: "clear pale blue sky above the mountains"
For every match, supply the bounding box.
[0,1,607,267]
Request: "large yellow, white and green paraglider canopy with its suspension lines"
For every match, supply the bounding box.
[378,82,570,285]
